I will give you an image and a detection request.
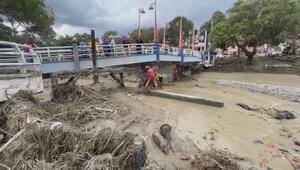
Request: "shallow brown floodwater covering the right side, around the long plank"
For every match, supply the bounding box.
[145,73,300,170]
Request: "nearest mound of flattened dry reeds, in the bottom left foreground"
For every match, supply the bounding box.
[0,122,145,170]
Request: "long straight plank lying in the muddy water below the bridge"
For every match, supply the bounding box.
[149,91,224,107]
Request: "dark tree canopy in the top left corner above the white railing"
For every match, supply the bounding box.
[0,0,55,42]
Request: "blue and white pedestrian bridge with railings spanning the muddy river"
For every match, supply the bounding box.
[0,41,213,74]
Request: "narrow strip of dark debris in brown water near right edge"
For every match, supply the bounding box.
[237,103,296,120]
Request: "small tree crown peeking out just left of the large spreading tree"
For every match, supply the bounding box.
[200,11,226,33]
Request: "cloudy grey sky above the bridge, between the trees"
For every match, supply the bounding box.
[46,0,236,36]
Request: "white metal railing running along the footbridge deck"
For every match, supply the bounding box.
[0,41,203,64]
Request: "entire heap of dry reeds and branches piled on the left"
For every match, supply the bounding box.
[0,83,146,170]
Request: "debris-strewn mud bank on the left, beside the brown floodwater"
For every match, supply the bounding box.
[0,75,239,170]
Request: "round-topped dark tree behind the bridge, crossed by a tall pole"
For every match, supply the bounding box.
[166,16,194,46]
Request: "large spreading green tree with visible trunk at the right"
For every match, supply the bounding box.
[211,0,300,64]
